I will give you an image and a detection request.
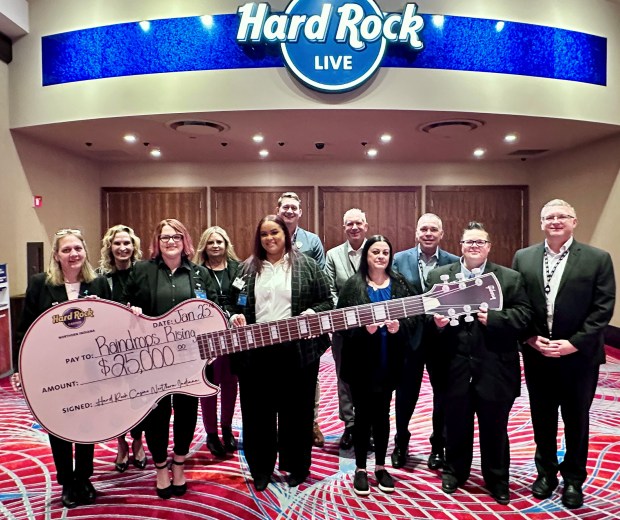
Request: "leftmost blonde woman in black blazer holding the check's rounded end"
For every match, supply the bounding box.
[11,229,111,508]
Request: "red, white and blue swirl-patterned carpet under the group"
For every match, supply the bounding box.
[0,349,620,520]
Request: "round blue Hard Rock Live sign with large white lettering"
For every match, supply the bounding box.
[237,0,424,92]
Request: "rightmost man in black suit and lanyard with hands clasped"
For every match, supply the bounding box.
[513,199,616,509]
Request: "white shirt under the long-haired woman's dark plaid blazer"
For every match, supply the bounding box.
[254,254,293,323]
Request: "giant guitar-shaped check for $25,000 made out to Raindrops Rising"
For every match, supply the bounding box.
[20,274,503,443]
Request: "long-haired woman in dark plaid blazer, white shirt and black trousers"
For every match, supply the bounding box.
[230,215,333,491]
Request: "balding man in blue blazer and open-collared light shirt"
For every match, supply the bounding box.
[392,213,459,469]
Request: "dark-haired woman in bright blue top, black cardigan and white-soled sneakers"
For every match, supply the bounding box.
[338,235,420,495]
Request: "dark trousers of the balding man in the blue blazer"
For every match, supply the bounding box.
[394,345,445,453]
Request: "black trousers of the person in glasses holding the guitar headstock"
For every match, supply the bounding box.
[443,386,514,485]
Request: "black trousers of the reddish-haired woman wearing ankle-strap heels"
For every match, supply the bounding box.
[144,394,198,464]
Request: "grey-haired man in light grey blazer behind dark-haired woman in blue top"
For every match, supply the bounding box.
[325,208,368,450]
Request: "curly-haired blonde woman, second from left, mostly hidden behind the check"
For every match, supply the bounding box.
[97,224,147,473]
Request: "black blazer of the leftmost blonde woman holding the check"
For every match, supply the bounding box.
[13,273,112,370]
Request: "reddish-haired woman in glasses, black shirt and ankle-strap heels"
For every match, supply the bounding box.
[123,218,217,499]
